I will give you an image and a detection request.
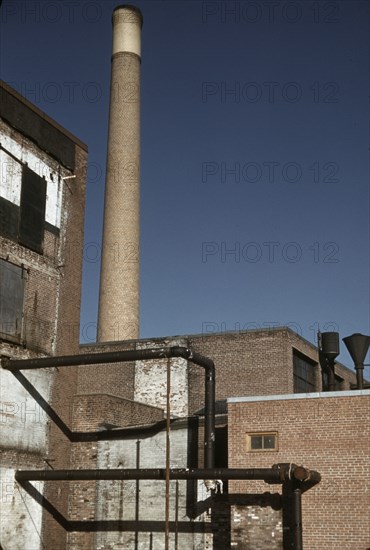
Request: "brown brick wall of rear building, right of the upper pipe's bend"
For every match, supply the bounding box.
[189,328,317,411]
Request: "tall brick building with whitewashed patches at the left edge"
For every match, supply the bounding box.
[0,82,87,550]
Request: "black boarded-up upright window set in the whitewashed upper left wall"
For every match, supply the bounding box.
[19,166,46,254]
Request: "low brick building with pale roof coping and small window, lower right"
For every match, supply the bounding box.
[228,390,370,550]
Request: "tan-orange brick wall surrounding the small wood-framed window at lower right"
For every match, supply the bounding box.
[228,392,370,550]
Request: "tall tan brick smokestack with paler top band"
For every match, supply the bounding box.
[98,5,143,342]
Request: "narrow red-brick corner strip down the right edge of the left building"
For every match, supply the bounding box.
[44,145,87,550]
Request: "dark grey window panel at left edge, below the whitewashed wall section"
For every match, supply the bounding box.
[0,260,24,342]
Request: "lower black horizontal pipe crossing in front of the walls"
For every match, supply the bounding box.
[15,464,320,483]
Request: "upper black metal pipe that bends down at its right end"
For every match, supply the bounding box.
[1,346,216,468]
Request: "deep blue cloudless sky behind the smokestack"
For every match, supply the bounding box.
[0,0,370,366]
